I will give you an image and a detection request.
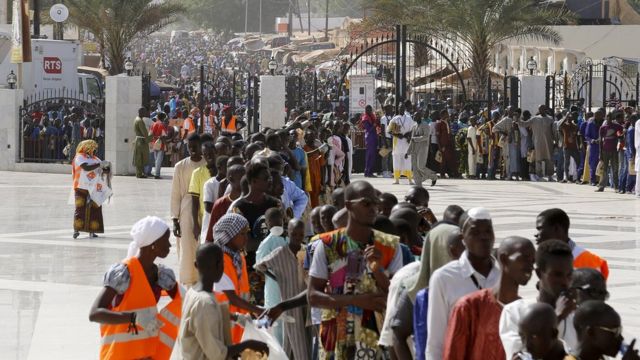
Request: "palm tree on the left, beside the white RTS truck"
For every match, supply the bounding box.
[65,0,184,75]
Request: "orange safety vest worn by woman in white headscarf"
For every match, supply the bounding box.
[100,257,182,360]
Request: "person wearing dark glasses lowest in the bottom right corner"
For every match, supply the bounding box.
[565,300,640,360]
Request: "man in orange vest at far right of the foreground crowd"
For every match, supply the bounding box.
[536,208,609,280]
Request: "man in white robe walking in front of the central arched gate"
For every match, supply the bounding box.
[387,101,414,184]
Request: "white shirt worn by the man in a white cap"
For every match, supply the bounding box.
[426,251,500,360]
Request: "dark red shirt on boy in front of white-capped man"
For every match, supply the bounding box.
[443,289,506,360]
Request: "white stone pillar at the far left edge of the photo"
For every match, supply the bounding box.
[0,89,23,171]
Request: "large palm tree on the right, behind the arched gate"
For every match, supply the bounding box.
[368,0,573,93]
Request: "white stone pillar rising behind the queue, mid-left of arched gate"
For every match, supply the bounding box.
[260,75,287,129]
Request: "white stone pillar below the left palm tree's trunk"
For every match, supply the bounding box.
[105,74,142,175]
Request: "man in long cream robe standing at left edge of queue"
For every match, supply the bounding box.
[171,134,206,286]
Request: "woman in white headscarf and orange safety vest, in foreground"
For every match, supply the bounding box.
[89,216,182,359]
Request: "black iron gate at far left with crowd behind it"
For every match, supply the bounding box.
[17,90,104,163]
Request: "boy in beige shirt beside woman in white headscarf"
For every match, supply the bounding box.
[180,243,269,360]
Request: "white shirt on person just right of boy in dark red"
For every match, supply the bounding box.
[500,299,578,360]
